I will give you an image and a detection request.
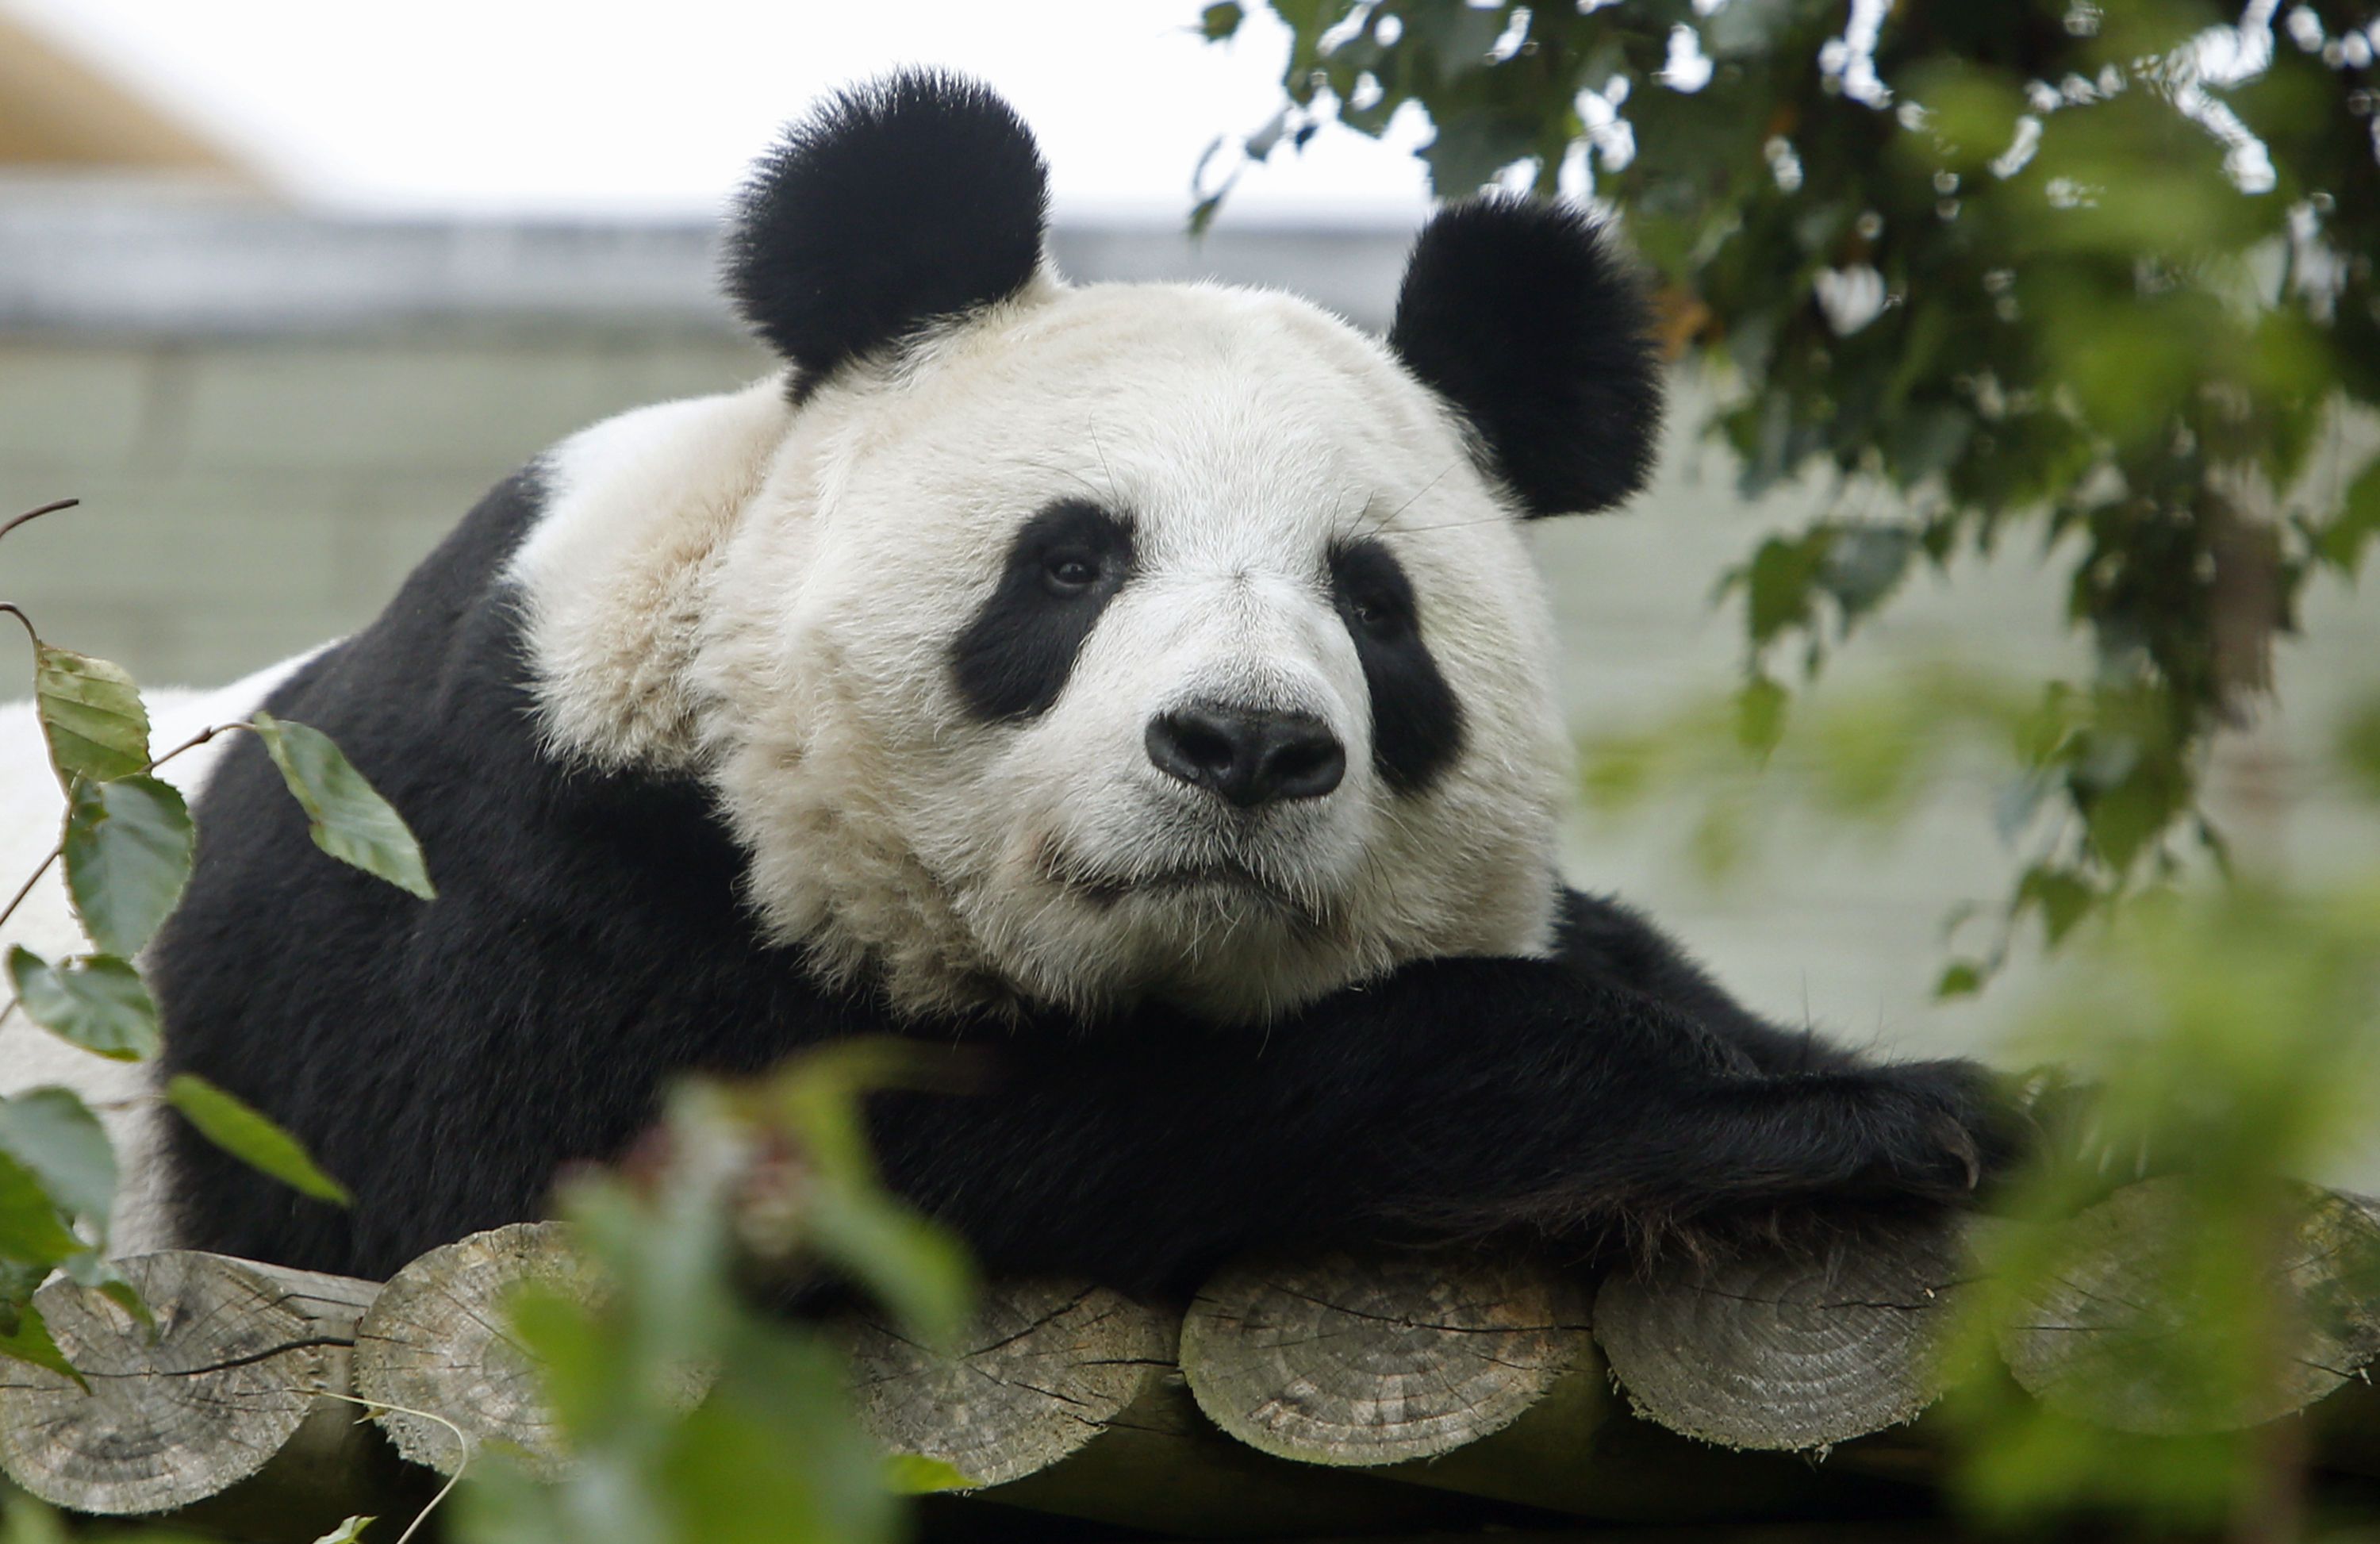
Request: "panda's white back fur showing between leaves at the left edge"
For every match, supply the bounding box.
[0,652,312,1254]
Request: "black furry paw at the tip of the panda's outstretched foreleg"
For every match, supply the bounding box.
[1861,1061,2035,1204]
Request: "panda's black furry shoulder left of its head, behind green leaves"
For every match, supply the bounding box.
[150,469,881,1280]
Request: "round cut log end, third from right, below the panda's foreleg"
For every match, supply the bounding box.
[1183,1254,1585,1465]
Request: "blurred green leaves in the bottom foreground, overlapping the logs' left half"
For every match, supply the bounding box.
[459,1042,971,1544]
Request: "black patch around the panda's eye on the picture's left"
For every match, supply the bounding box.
[950,500,1133,724]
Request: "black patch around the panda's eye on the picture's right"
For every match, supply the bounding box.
[1330,540,1464,794]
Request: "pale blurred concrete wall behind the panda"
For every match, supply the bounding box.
[0,202,2380,1080]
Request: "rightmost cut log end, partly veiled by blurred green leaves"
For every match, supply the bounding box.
[1999,1175,2380,1435]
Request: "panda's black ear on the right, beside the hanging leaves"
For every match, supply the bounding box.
[1388,195,1661,517]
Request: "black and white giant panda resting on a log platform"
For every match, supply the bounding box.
[10,71,2013,1289]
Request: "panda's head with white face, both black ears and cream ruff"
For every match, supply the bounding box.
[524,74,1659,1020]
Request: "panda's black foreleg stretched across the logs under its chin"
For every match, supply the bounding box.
[873,958,2013,1289]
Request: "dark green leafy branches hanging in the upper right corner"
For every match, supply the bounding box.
[1197,0,2380,975]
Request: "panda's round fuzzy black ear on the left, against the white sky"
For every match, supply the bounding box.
[726,69,1050,388]
